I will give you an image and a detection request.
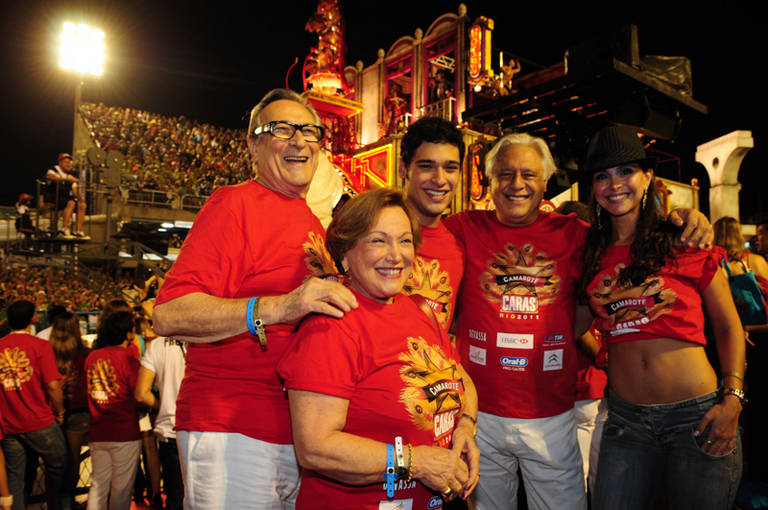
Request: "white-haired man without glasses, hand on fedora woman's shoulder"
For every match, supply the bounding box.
[444,133,711,510]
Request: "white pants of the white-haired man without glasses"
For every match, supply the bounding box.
[475,410,587,510]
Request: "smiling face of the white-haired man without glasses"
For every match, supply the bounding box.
[491,145,548,227]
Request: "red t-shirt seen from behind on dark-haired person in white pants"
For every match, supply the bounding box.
[85,345,141,441]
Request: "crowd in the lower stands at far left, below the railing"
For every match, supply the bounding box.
[0,260,133,312]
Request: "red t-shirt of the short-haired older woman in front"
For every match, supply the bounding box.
[278,293,464,510]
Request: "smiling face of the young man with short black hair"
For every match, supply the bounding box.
[400,142,461,227]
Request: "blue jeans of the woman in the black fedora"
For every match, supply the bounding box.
[594,392,742,510]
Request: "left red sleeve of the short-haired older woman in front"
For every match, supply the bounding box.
[278,316,361,399]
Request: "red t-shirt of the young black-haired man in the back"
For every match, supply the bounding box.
[404,222,464,331]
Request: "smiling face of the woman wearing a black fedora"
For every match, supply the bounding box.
[592,163,653,219]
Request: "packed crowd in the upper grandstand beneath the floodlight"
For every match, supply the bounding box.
[80,103,251,196]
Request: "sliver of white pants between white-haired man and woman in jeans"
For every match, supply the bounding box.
[573,398,608,490]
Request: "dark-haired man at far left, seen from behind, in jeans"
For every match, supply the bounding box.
[0,300,72,510]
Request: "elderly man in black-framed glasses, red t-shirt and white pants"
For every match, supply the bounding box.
[154,89,364,509]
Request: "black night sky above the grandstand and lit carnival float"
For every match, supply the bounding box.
[0,0,768,222]
